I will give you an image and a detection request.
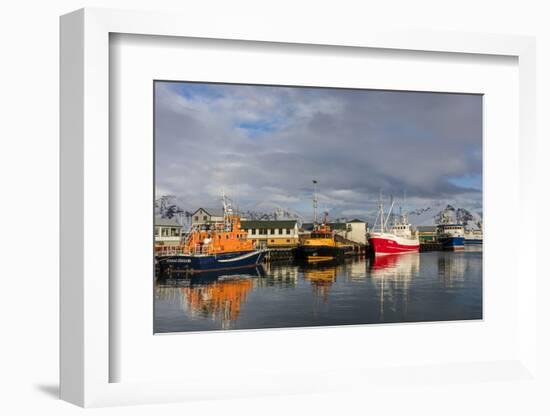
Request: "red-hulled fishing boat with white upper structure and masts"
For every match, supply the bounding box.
[368,197,420,254]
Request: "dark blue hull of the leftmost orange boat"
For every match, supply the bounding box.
[159,251,266,275]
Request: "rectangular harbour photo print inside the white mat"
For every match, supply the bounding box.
[153,80,483,333]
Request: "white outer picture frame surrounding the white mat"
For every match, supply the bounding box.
[60,9,538,407]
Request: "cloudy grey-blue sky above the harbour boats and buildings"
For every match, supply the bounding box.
[155,82,482,218]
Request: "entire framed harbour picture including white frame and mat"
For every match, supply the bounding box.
[61,9,537,406]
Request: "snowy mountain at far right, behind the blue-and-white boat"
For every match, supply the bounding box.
[409,201,483,229]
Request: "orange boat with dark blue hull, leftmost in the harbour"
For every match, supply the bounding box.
[157,196,266,275]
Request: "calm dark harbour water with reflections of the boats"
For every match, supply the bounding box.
[154,246,483,333]
